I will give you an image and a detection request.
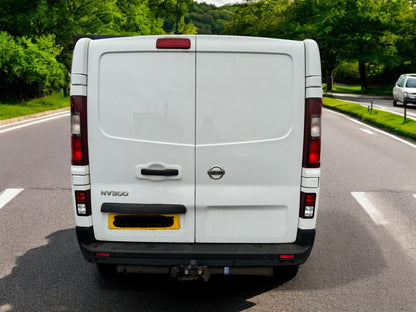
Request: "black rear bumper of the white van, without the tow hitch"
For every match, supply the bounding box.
[76,227,315,267]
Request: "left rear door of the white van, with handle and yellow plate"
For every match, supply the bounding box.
[88,37,195,242]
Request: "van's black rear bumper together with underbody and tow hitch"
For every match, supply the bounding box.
[76,227,315,281]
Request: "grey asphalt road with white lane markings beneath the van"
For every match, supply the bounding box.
[0,110,416,312]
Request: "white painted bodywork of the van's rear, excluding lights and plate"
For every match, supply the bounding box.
[71,36,322,243]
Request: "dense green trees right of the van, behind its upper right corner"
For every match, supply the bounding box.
[227,0,416,90]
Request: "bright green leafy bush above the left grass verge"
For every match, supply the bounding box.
[0,32,67,101]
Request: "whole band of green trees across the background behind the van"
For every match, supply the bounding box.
[0,0,416,100]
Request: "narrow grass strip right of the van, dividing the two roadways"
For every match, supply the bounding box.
[323,97,416,140]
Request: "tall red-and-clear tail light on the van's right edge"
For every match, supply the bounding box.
[303,98,322,168]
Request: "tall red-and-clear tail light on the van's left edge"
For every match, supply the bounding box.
[71,96,89,166]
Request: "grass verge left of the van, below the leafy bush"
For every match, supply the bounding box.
[0,94,69,120]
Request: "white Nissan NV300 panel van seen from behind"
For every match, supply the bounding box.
[71,35,322,279]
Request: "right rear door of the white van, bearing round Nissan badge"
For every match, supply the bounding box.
[196,36,305,243]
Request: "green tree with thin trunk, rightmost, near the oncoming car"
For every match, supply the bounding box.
[330,0,412,91]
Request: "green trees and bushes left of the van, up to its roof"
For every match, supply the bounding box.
[0,0,164,100]
